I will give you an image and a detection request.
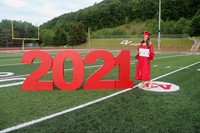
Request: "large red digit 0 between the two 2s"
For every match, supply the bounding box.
[52,50,84,90]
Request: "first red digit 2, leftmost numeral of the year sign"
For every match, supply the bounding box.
[21,51,53,90]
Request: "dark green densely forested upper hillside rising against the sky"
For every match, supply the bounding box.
[41,0,200,30]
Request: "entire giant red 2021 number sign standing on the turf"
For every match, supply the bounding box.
[21,50,133,90]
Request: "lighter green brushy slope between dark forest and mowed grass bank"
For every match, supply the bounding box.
[91,17,195,38]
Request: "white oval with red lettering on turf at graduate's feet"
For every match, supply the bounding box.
[141,81,180,92]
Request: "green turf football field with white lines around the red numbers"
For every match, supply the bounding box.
[0,50,200,133]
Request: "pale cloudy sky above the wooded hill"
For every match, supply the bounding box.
[0,0,103,26]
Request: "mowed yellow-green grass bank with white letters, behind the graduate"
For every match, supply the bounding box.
[85,38,194,51]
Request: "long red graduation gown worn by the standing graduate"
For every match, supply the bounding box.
[135,44,154,81]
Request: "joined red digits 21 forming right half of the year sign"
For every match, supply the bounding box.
[84,50,133,90]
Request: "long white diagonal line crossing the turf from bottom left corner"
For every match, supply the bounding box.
[0,61,200,133]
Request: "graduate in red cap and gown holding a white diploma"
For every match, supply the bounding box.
[135,31,154,89]
